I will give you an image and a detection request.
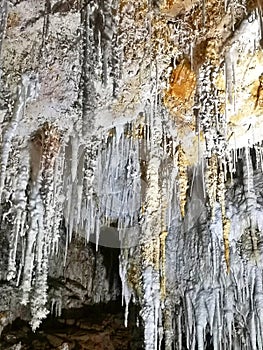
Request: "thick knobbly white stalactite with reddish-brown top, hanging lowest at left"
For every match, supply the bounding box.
[19,124,61,330]
